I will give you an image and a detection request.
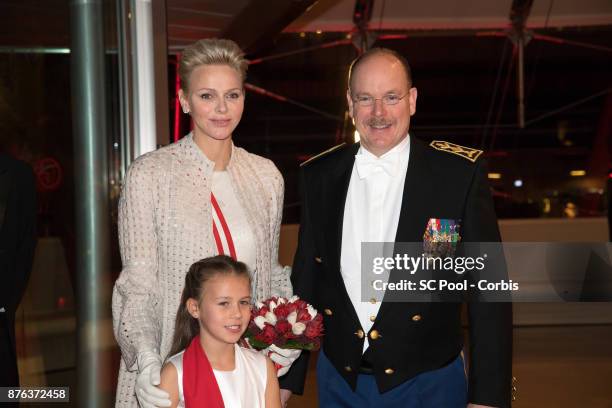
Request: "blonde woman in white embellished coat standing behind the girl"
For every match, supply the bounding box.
[113,39,297,408]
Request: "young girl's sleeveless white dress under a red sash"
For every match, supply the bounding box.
[168,345,268,408]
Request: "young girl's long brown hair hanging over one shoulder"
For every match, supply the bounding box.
[168,255,251,357]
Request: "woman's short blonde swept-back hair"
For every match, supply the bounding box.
[179,38,249,92]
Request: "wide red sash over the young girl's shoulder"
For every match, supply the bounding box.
[183,335,225,408]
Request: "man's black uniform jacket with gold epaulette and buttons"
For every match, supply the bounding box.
[281,138,512,407]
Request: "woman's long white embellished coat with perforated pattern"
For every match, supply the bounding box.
[112,135,291,407]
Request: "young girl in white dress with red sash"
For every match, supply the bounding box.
[159,255,281,408]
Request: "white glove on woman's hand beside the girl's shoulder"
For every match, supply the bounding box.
[135,351,171,408]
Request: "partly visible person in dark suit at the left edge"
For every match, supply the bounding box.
[0,153,36,387]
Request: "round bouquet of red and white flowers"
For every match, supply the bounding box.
[244,296,323,350]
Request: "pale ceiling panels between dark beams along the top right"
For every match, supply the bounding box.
[285,0,612,32]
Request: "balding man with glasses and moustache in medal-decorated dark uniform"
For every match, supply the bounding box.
[281,48,512,408]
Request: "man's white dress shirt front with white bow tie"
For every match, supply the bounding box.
[340,135,410,352]
